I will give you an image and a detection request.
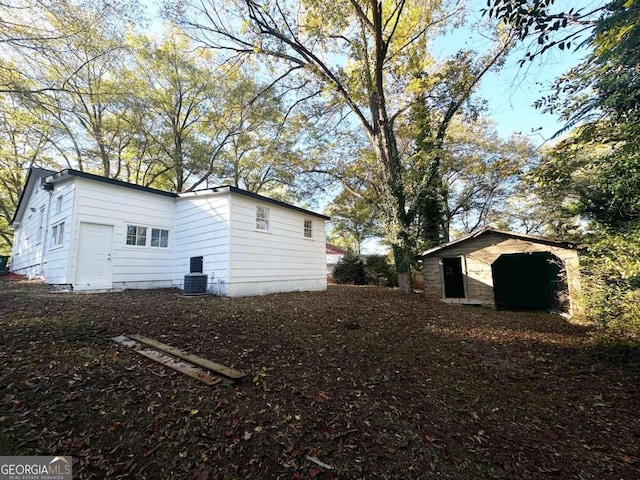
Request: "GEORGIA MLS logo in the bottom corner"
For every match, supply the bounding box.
[0,456,73,480]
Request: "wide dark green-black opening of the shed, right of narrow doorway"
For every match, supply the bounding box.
[491,252,560,310]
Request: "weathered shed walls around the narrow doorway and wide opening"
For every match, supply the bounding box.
[423,233,582,316]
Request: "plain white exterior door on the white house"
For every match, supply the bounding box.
[74,223,113,290]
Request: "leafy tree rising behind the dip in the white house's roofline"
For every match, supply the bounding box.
[129,26,235,192]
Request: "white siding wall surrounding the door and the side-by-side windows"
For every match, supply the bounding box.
[69,178,175,288]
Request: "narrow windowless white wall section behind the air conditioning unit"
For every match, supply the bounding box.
[172,192,229,295]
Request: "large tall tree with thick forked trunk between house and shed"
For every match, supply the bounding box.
[172,0,509,293]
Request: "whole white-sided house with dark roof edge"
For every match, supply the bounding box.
[11,168,328,297]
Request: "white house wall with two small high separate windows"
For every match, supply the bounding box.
[228,194,327,297]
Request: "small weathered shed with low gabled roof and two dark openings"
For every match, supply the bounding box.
[418,227,582,316]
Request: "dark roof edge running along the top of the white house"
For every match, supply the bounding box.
[11,167,330,224]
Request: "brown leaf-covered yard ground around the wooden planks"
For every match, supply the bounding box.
[0,277,640,480]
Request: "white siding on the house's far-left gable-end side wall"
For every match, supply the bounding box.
[11,179,50,278]
